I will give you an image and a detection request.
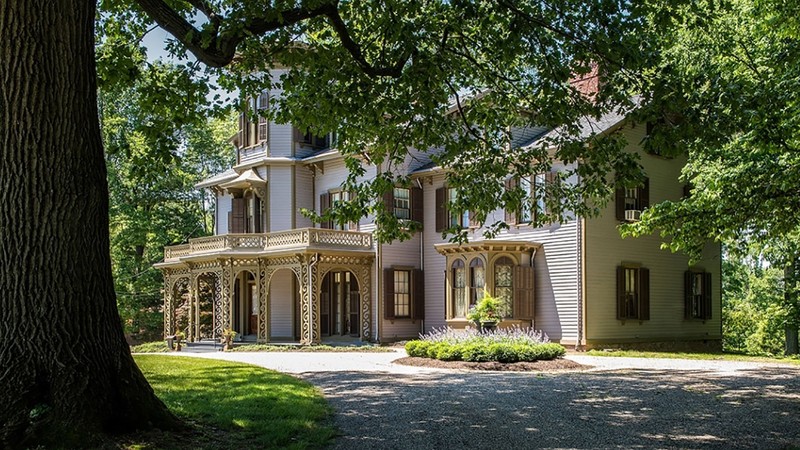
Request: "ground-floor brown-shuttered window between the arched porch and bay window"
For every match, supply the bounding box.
[383,268,425,320]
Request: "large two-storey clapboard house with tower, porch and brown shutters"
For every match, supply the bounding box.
[156,67,721,346]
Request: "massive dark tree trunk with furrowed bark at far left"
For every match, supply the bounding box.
[0,0,178,448]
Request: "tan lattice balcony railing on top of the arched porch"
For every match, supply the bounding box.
[164,228,372,263]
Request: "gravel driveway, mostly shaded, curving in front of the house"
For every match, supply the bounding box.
[181,353,800,449]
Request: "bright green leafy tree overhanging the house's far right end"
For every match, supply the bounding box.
[624,0,800,352]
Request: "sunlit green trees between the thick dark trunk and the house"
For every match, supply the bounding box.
[100,67,235,342]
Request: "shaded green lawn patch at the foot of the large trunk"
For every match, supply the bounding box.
[123,355,335,449]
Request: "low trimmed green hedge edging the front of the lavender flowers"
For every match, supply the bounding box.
[406,341,567,363]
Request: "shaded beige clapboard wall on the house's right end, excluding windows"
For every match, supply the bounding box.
[585,125,721,344]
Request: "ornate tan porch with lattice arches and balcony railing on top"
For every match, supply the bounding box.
[155,228,375,345]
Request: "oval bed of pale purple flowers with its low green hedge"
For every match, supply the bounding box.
[406,327,566,363]
